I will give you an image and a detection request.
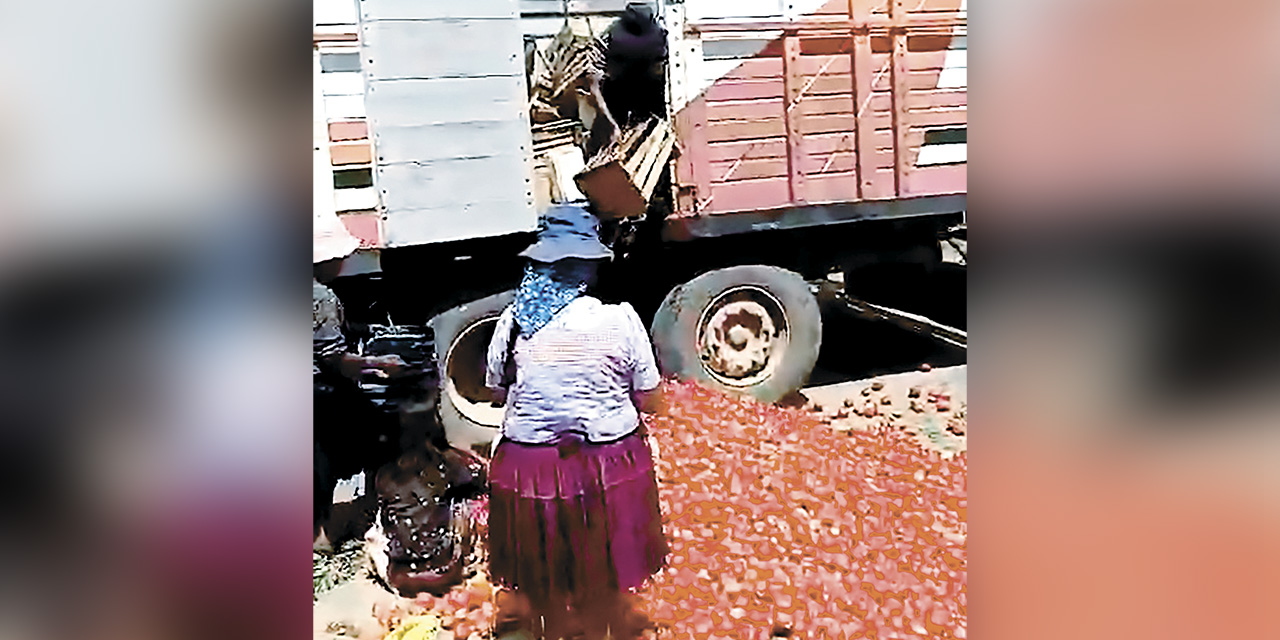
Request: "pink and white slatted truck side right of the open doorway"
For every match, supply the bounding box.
[668,0,966,237]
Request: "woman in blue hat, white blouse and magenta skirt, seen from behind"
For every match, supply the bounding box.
[486,206,667,639]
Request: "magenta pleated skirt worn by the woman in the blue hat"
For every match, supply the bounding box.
[489,434,667,600]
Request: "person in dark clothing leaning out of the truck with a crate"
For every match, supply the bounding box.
[585,3,667,157]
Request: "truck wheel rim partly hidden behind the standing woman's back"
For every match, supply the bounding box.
[443,316,506,429]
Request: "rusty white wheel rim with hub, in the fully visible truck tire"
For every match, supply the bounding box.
[696,285,790,387]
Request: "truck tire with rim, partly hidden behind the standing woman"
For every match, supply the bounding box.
[429,291,516,456]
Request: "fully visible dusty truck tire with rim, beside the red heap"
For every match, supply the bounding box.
[653,265,822,402]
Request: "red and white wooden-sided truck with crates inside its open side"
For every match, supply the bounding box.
[316,0,966,444]
